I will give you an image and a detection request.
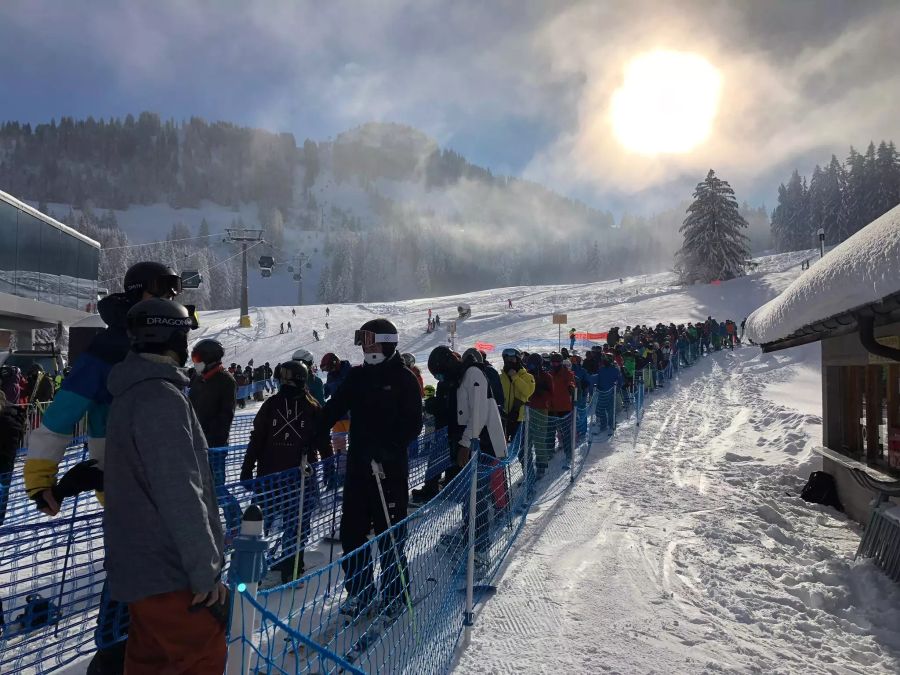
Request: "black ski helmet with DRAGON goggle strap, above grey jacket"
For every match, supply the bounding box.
[126,298,193,365]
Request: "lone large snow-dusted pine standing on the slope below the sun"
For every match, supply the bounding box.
[675,169,750,284]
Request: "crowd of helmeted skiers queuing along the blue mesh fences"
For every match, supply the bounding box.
[0,255,737,673]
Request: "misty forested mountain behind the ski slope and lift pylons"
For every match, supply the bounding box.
[0,112,712,306]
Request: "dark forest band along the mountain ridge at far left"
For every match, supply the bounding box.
[0,112,297,211]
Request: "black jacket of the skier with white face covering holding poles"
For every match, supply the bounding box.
[320,352,422,473]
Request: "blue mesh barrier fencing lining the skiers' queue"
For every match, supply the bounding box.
[0,342,716,673]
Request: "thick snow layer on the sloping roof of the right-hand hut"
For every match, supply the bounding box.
[746,206,900,345]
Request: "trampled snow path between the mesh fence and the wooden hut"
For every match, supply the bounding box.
[456,348,900,674]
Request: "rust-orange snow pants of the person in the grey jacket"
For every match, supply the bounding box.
[125,591,226,675]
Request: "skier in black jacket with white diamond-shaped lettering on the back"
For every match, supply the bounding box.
[241,361,332,584]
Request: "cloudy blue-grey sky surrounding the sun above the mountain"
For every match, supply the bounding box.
[0,0,900,211]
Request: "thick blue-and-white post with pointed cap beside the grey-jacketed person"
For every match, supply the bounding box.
[225,504,266,675]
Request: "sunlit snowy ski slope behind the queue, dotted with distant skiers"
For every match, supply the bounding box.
[192,251,810,375]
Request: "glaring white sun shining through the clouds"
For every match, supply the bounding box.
[610,51,722,155]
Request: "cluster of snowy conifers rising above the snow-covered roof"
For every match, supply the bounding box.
[772,141,900,252]
